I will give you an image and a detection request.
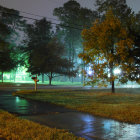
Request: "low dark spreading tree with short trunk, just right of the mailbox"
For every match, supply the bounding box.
[28,39,76,85]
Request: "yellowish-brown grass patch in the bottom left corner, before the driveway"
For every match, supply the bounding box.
[0,110,84,140]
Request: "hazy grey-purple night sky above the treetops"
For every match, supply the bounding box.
[0,0,140,18]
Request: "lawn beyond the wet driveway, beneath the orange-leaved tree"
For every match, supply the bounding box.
[15,89,140,124]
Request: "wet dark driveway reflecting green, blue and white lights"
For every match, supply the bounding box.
[0,90,140,140]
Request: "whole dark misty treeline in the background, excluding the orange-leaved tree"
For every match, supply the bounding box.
[0,0,140,84]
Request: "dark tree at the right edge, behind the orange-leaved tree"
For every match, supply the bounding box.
[96,0,140,83]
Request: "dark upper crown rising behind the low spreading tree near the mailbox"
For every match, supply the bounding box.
[25,18,52,51]
